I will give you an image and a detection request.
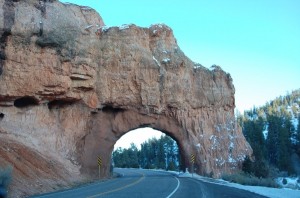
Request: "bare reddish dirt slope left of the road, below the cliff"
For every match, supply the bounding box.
[0,137,85,198]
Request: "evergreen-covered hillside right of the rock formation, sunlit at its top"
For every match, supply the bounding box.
[238,89,300,177]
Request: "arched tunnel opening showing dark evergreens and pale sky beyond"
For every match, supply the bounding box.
[112,126,183,171]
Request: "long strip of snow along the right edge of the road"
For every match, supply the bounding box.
[178,172,300,198]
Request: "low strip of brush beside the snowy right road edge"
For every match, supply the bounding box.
[222,172,279,188]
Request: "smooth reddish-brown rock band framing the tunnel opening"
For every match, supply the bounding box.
[77,109,197,177]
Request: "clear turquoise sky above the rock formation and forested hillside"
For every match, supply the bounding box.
[61,0,300,111]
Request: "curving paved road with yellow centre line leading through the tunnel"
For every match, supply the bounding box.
[35,169,264,198]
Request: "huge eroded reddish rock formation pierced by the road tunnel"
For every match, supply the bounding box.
[0,0,252,183]
